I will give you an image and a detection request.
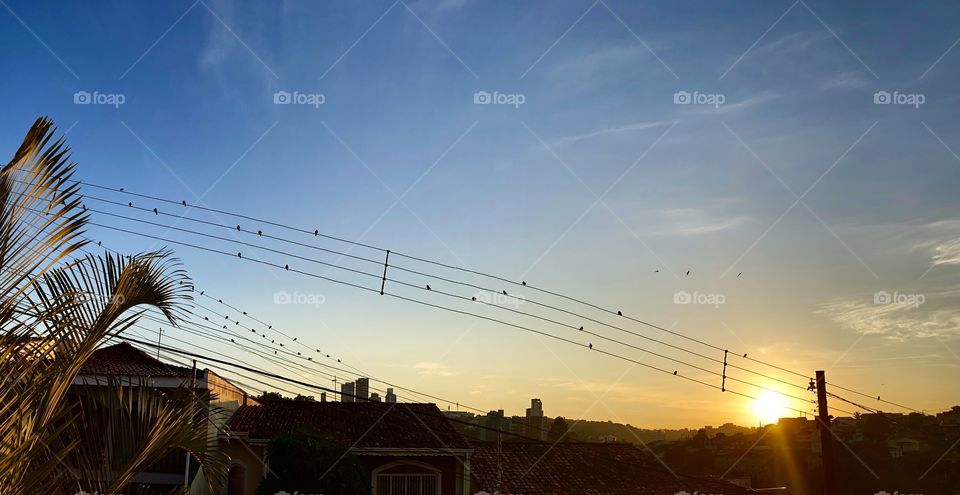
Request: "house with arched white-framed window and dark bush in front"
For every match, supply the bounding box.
[226,401,473,495]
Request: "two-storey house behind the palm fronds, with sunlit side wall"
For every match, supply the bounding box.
[70,342,257,493]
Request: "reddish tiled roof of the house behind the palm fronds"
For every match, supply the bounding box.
[79,342,202,378]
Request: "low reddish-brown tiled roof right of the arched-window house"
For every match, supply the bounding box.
[471,442,752,495]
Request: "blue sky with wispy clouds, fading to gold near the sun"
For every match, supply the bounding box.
[0,0,960,428]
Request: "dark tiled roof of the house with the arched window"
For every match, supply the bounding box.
[229,401,471,451]
